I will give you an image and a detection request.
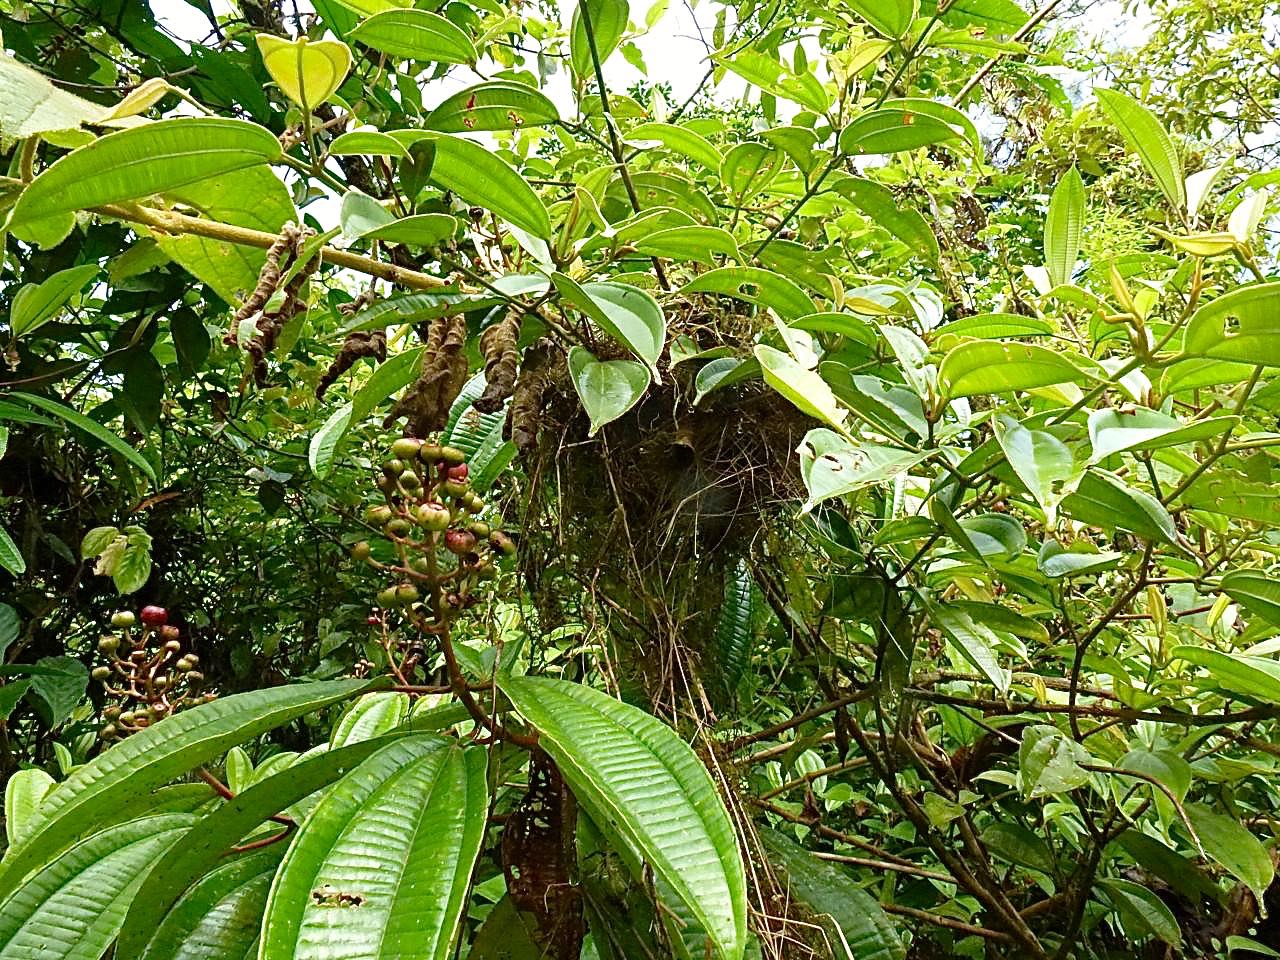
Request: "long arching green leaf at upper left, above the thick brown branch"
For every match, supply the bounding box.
[9,116,280,247]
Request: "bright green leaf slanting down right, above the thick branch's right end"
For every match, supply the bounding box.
[413,131,552,239]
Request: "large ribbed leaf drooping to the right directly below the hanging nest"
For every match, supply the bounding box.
[499,677,746,960]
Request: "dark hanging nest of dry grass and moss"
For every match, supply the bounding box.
[508,308,813,718]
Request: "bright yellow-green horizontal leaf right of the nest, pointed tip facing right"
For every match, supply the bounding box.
[938,340,1088,398]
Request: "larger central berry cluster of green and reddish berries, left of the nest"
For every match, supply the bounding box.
[352,438,516,613]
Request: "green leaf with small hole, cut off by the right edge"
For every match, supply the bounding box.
[1183,283,1280,366]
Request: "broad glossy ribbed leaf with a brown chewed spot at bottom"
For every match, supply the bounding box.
[260,737,489,960]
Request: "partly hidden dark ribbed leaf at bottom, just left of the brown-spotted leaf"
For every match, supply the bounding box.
[141,844,285,960]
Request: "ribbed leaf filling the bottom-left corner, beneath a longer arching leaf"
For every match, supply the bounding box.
[0,814,192,960]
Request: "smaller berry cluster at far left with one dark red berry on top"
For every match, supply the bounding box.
[92,607,216,740]
